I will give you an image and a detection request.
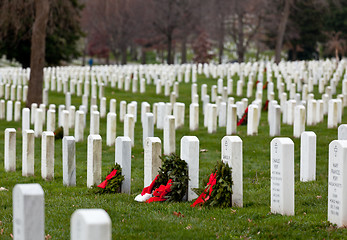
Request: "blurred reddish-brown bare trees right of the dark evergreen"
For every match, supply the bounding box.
[82,0,347,64]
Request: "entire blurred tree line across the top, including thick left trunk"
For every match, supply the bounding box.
[0,0,347,105]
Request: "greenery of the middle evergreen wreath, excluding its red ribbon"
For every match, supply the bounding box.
[153,154,189,202]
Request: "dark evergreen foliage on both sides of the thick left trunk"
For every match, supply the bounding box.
[0,0,83,67]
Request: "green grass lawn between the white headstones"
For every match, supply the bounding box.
[0,75,347,239]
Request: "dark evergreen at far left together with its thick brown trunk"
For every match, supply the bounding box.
[0,0,81,106]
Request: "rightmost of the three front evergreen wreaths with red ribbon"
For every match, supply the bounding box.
[194,160,233,208]
